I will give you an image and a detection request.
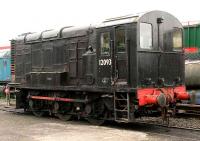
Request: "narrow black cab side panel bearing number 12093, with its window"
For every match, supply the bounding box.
[97,27,114,87]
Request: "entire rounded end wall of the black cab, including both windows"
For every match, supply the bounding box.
[137,11,184,87]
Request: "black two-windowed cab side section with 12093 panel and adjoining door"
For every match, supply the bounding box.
[97,26,128,87]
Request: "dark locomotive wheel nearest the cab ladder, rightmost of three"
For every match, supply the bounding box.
[85,101,106,125]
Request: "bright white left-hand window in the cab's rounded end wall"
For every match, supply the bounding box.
[140,23,152,49]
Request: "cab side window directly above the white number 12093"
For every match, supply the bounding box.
[101,32,110,55]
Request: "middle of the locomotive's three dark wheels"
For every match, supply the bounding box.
[54,102,72,121]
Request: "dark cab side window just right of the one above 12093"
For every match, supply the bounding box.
[115,29,125,52]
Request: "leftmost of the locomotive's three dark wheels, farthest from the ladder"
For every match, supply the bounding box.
[29,100,45,117]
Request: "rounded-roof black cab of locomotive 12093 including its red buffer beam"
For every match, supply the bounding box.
[97,11,189,114]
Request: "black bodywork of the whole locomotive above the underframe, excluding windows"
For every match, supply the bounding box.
[11,11,184,92]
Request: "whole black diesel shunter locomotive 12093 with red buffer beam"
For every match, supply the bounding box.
[11,11,188,124]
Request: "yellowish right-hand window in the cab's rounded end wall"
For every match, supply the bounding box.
[172,29,182,50]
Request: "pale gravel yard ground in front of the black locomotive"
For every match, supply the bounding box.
[0,101,200,141]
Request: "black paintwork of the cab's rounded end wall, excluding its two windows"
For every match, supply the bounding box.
[137,11,184,86]
